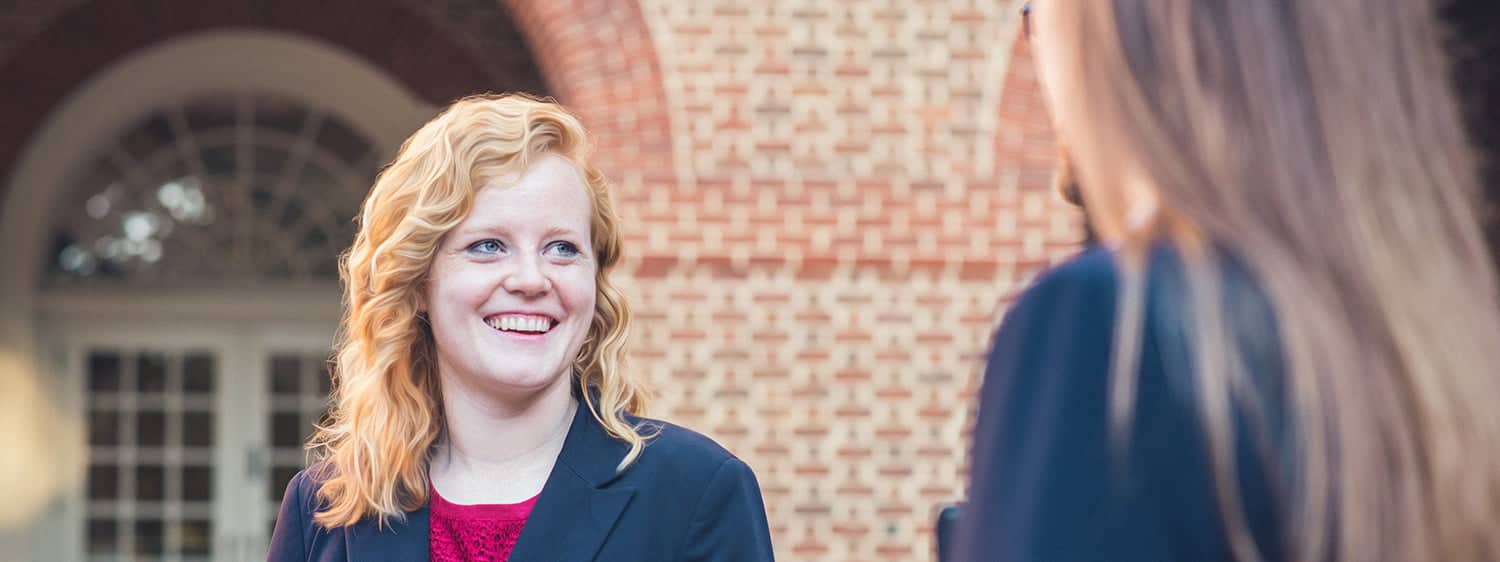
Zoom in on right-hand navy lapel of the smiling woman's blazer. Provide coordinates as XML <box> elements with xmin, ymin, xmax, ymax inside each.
<box><xmin>510</xmin><ymin>400</ymin><xmax>635</xmax><ymax>562</ymax></box>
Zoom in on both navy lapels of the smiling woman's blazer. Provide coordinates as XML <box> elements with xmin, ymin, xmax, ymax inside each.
<box><xmin>345</xmin><ymin>400</ymin><xmax>635</xmax><ymax>562</ymax></box>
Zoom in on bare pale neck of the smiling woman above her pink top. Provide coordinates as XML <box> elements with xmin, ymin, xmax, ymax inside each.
<box><xmin>429</xmin><ymin>378</ymin><xmax>578</xmax><ymax>504</ymax></box>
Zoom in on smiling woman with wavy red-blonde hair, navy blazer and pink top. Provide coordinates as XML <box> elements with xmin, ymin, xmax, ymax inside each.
<box><xmin>270</xmin><ymin>96</ymin><xmax>771</xmax><ymax>561</ymax></box>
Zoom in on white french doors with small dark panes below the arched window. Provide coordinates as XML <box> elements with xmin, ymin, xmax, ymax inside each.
<box><xmin>51</xmin><ymin>313</ymin><xmax>340</xmax><ymax>562</ymax></box>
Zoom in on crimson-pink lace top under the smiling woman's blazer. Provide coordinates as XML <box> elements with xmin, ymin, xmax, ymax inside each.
<box><xmin>428</xmin><ymin>487</ymin><xmax>537</xmax><ymax>562</ymax></box>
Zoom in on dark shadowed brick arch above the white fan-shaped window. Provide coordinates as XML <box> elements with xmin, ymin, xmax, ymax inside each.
<box><xmin>0</xmin><ymin>0</ymin><xmax>548</xmax><ymax>205</ymax></box>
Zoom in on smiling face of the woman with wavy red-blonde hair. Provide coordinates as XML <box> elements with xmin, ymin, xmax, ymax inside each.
<box><xmin>425</xmin><ymin>154</ymin><xmax>599</xmax><ymax>397</ymax></box>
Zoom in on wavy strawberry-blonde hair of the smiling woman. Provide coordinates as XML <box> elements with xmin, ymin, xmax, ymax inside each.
<box><xmin>308</xmin><ymin>94</ymin><xmax>645</xmax><ymax>528</ymax></box>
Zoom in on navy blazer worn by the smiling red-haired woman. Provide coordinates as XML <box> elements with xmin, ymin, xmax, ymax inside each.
<box><xmin>267</xmin><ymin>408</ymin><xmax>773</xmax><ymax>562</ymax></box>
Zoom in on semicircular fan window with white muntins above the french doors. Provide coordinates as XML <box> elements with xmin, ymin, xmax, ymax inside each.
<box><xmin>45</xmin><ymin>91</ymin><xmax>380</xmax><ymax>288</ymax></box>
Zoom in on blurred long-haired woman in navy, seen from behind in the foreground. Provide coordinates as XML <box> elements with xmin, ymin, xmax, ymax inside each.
<box><xmin>960</xmin><ymin>0</ymin><xmax>1500</xmax><ymax>562</ymax></box>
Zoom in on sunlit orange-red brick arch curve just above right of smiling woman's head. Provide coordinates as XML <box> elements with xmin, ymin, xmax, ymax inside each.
<box><xmin>497</xmin><ymin>0</ymin><xmax>672</xmax><ymax>178</ymax></box>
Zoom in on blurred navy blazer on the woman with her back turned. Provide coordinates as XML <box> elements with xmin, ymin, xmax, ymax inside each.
<box><xmin>957</xmin><ymin>247</ymin><xmax>1287</xmax><ymax>562</ymax></box>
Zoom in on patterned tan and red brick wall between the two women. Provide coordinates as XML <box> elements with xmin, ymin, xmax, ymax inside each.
<box><xmin>617</xmin><ymin>0</ymin><xmax>1080</xmax><ymax>562</ymax></box>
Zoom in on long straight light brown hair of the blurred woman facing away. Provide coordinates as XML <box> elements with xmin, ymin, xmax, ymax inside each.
<box><xmin>1038</xmin><ymin>0</ymin><xmax>1500</xmax><ymax>561</ymax></box>
